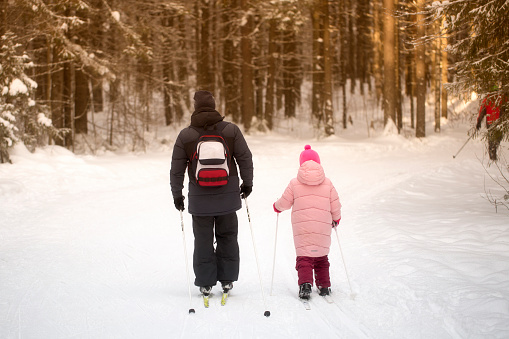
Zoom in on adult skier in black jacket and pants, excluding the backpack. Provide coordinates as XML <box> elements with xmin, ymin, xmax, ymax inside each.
<box><xmin>170</xmin><ymin>91</ymin><xmax>253</xmax><ymax>297</ymax></box>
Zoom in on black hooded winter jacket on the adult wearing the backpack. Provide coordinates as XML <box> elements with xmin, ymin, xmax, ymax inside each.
<box><xmin>170</xmin><ymin>108</ymin><xmax>253</xmax><ymax>216</ymax></box>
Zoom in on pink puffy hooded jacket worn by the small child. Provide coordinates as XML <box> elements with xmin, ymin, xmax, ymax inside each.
<box><xmin>274</xmin><ymin>160</ymin><xmax>341</xmax><ymax>257</ymax></box>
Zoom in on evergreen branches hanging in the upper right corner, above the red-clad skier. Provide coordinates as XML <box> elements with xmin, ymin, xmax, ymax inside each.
<box><xmin>432</xmin><ymin>0</ymin><xmax>509</xmax><ymax>140</ymax></box>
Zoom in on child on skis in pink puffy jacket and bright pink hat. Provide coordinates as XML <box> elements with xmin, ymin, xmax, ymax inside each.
<box><xmin>273</xmin><ymin>145</ymin><xmax>341</xmax><ymax>299</ymax></box>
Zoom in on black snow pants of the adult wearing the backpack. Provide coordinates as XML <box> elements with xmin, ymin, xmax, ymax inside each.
<box><xmin>193</xmin><ymin>212</ymin><xmax>240</xmax><ymax>286</ymax></box>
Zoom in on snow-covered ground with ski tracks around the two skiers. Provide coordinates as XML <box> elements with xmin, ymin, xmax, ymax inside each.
<box><xmin>0</xmin><ymin>121</ymin><xmax>509</xmax><ymax>338</ymax></box>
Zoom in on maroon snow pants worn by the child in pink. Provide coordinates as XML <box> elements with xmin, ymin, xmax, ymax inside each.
<box><xmin>295</xmin><ymin>255</ymin><xmax>330</xmax><ymax>287</ymax></box>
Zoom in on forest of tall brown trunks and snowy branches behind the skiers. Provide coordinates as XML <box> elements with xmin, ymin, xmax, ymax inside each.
<box><xmin>0</xmin><ymin>0</ymin><xmax>509</xmax><ymax>162</ymax></box>
